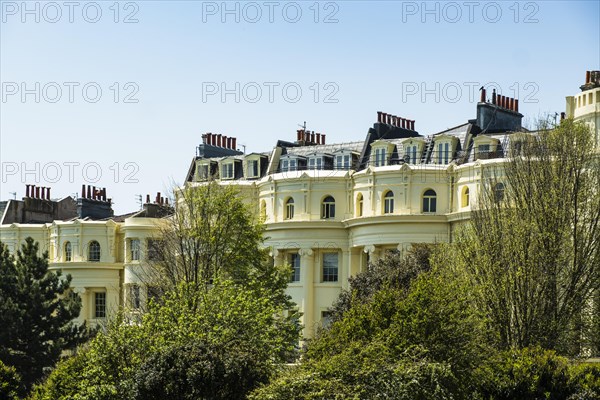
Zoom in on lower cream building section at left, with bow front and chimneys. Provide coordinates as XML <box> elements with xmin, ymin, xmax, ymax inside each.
<box><xmin>0</xmin><ymin>185</ymin><xmax>170</xmax><ymax>325</ymax></box>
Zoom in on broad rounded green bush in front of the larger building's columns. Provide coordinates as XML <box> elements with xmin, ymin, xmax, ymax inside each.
<box><xmin>252</xmin><ymin>247</ymin><xmax>488</xmax><ymax>399</ymax></box>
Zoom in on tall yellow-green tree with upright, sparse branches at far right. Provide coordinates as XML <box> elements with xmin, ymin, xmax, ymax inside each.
<box><xmin>454</xmin><ymin>120</ymin><xmax>600</xmax><ymax>355</ymax></box>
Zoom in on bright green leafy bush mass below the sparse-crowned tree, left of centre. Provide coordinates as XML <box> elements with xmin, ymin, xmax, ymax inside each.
<box><xmin>36</xmin><ymin>281</ymin><xmax>300</xmax><ymax>400</ymax></box>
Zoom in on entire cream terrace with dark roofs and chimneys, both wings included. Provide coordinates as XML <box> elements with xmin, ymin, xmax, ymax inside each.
<box><xmin>0</xmin><ymin>71</ymin><xmax>600</xmax><ymax>336</ymax></box>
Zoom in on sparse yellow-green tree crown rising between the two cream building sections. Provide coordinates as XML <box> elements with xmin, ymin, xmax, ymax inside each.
<box><xmin>145</xmin><ymin>182</ymin><xmax>266</xmax><ymax>288</ymax></box>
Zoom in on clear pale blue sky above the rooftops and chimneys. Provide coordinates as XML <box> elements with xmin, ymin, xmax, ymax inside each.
<box><xmin>0</xmin><ymin>0</ymin><xmax>600</xmax><ymax>214</ymax></box>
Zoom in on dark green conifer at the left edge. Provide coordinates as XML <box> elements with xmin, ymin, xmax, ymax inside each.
<box><xmin>0</xmin><ymin>237</ymin><xmax>86</xmax><ymax>390</ymax></box>
